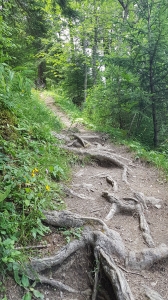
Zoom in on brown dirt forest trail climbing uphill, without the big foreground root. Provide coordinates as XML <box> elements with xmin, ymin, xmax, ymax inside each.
<box><xmin>35</xmin><ymin>97</ymin><xmax>168</xmax><ymax>300</ymax></box>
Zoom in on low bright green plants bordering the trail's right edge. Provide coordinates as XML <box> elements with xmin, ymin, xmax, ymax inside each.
<box><xmin>52</xmin><ymin>86</ymin><xmax>168</xmax><ymax>174</ymax></box>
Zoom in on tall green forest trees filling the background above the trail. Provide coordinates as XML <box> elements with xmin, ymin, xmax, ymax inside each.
<box><xmin>0</xmin><ymin>0</ymin><xmax>168</xmax><ymax>147</ymax></box>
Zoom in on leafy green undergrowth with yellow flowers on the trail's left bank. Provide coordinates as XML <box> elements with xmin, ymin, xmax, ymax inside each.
<box><xmin>0</xmin><ymin>65</ymin><xmax>73</xmax><ymax>300</ymax></box>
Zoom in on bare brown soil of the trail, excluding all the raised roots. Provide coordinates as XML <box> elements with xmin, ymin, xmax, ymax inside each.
<box><xmin>0</xmin><ymin>97</ymin><xmax>168</xmax><ymax>300</ymax></box>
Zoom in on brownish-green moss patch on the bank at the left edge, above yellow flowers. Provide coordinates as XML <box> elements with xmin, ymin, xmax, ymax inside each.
<box><xmin>0</xmin><ymin>109</ymin><xmax>17</xmax><ymax>140</ymax></box>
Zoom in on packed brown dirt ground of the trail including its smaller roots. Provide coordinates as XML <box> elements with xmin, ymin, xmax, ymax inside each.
<box><xmin>0</xmin><ymin>97</ymin><xmax>168</xmax><ymax>300</ymax></box>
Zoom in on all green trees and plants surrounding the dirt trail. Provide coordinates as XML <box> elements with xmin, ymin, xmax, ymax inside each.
<box><xmin>0</xmin><ymin>0</ymin><xmax>168</xmax><ymax>298</ymax></box>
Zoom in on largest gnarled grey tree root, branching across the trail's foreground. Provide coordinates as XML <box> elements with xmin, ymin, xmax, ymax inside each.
<box><xmin>23</xmin><ymin>211</ymin><xmax>168</xmax><ymax>300</ymax></box>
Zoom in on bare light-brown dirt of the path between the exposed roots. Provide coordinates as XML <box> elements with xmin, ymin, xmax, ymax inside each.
<box><xmin>38</xmin><ymin>98</ymin><xmax>168</xmax><ymax>300</ymax></box>
